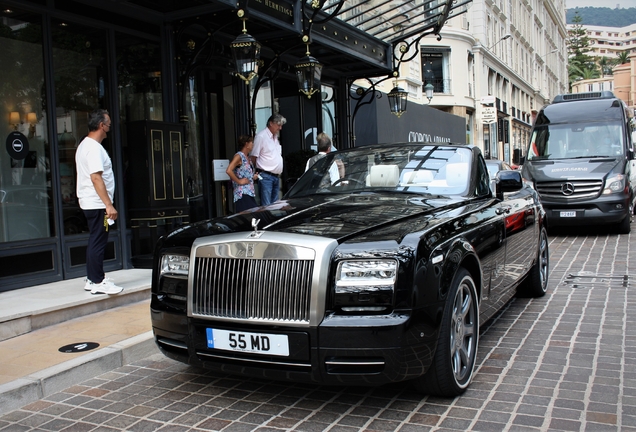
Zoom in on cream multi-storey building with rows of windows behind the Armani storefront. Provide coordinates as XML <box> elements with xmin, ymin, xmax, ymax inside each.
<box><xmin>366</xmin><ymin>0</ymin><xmax>568</xmax><ymax>162</ymax></box>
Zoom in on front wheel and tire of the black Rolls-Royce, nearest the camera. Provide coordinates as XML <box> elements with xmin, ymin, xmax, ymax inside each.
<box><xmin>414</xmin><ymin>268</ymin><xmax>479</xmax><ymax>397</ymax></box>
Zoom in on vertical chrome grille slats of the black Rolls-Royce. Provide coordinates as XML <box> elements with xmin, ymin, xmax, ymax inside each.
<box><xmin>192</xmin><ymin>257</ymin><xmax>314</xmax><ymax>323</ymax></box>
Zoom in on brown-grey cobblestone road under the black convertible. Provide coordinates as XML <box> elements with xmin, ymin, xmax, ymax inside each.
<box><xmin>0</xmin><ymin>225</ymin><xmax>636</xmax><ymax>432</ymax></box>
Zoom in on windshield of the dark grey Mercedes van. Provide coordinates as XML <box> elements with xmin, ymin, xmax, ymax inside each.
<box><xmin>527</xmin><ymin>121</ymin><xmax>624</xmax><ymax>160</ymax></box>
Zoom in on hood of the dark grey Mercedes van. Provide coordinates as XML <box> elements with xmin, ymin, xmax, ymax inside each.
<box><xmin>523</xmin><ymin>157</ymin><xmax>622</xmax><ymax>182</ymax></box>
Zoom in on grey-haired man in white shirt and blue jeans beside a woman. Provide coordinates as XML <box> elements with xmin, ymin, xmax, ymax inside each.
<box><xmin>250</xmin><ymin>114</ymin><xmax>287</xmax><ymax>205</ymax></box>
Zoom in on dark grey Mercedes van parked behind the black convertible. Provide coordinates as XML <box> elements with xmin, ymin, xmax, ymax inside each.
<box><xmin>522</xmin><ymin>91</ymin><xmax>636</xmax><ymax>234</ymax></box>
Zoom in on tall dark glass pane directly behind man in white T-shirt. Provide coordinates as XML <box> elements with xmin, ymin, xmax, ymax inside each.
<box><xmin>51</xmin><ymin>20</ymin><xmax>109</xmax><ymax>234</ymax></box>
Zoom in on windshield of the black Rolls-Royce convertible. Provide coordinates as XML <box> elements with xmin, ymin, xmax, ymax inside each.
<box><xmin>287</xmin><ymin>144</ymin><xmax>472</xmax><ymax>198</ymax></box>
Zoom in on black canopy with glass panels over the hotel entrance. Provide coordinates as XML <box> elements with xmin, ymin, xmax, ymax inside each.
<box><xmin>4</xmin><ymin>0</ymin><xmax>472</xmax><ymax>82</ymax></box>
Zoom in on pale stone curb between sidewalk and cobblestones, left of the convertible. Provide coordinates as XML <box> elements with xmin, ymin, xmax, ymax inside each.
<box><xmin>0</xmin><ymin>330</ymin><xmax>159</xmax><ymax>415</ymax></box>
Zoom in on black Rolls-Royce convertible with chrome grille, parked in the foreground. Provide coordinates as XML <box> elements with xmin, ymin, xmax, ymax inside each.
<box><xmin>151</xmin><ymin>143</ymin><xmax>549</xmax><ymax>396</ymax></box>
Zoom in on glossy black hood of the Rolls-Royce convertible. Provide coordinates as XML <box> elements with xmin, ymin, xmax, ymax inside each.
<box><xmin>160</xmin><ymin>193</ymin><xmax>466</xmax><ymax>247</ymax></box>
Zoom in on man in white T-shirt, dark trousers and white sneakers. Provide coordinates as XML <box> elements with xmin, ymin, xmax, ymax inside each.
<box><xmin>75</xmin><ymin>109</ymin><xmax>123</xmax><ymax>294</ymax></box>
